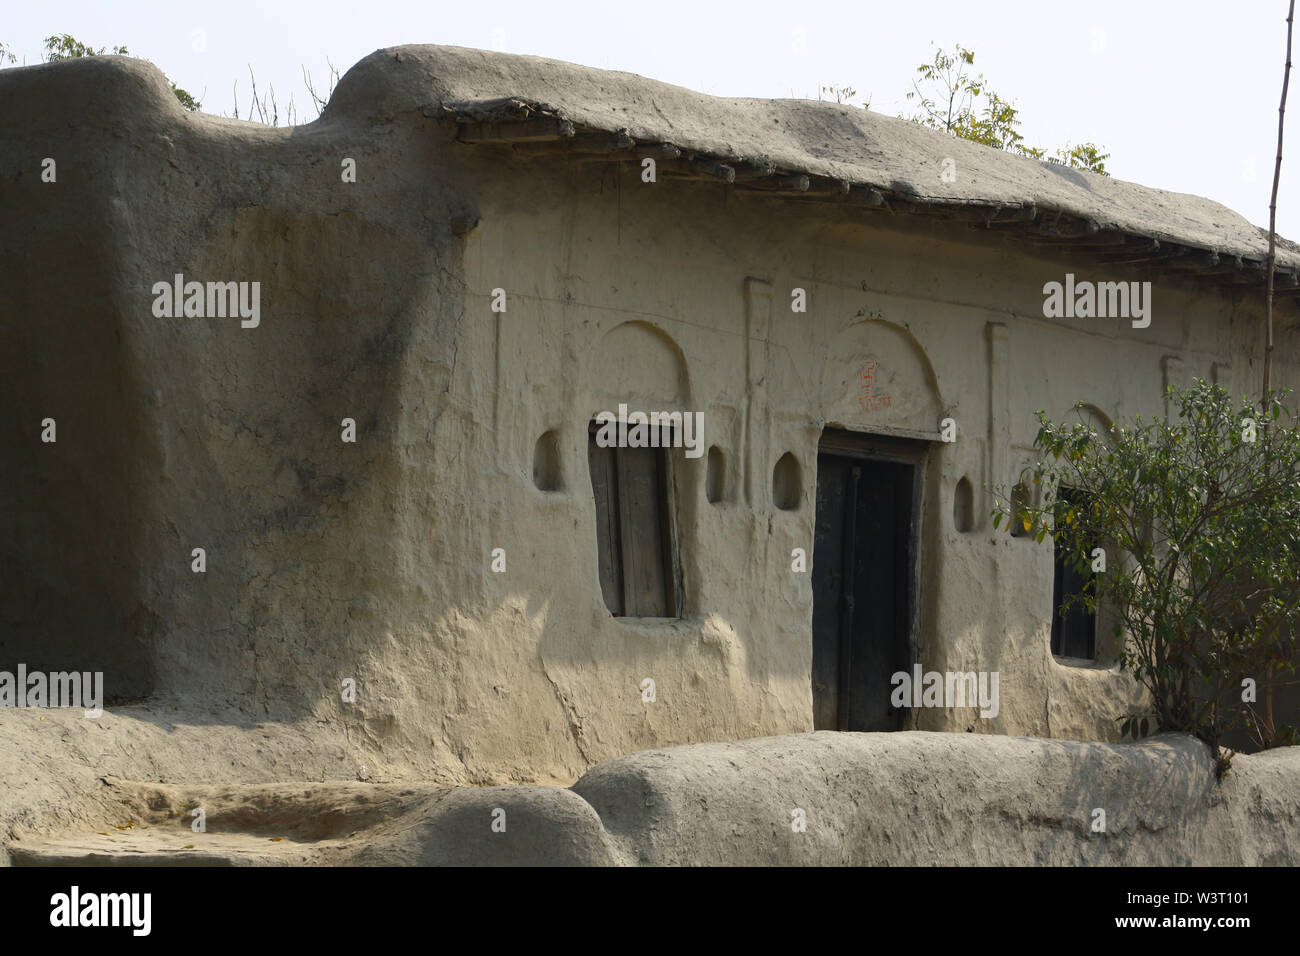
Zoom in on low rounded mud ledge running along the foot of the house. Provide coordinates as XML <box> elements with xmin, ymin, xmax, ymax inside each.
<box><xmin>0</xmin><ymin>711</ymin><xmax>1300</xmax><ymax>866</ymax></box>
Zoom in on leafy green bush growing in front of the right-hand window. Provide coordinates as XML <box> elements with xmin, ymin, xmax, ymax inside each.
<box><xmin>993</xmin><ymin>380</ymin><xmax>1300</xmax><ymax>771</ymax></box>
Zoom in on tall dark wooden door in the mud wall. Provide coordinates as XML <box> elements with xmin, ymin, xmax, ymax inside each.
<box><xmin>813</xmin><ymin>450</ymin><xmax>917</xmax><ymax>731</ymax></box>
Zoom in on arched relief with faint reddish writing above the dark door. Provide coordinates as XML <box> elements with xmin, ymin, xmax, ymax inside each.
<box><xmin>822</xmin><ymin>319</ymin><xmax>944</xmax><ymax>436</ymax></box>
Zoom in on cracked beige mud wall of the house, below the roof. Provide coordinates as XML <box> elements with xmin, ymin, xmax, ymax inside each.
<box><xmin>0</xmin><ymin>48</ymin><xmax>1296</xmax><ymax>783</ymax></box>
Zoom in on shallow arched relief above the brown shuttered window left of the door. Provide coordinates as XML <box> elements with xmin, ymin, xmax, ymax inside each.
<box><xmin>586</xmin><ymin>320</ymin><xmax>694</xmax><ymax>411</ymax></box>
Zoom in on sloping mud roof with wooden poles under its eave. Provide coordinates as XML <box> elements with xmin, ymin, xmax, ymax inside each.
<box><xmin>325</xmin><ymin>46</ymin><xmax>1300</xmax><ymax>290</ymax></box>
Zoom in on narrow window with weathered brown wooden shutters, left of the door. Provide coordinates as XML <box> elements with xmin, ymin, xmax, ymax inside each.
<box><xmin>588</xmin><ymin>424</ymin><xmax>681</xmax><ymax>618</ymax></box>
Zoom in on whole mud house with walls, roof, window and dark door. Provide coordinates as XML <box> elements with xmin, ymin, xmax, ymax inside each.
<box><xmin>0</xmin><ymin>47</ymin><xmax>1300</xmax><ymax>782</ymax></box>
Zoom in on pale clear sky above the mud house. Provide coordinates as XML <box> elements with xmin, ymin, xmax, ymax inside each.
<box><xmin>0</xmin><ymin>0</ymin><xmax>1300</xmax><ymax>239</ymax></box>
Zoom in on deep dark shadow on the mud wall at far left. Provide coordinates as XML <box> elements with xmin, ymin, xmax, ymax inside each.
<box><xmin>0</xmin><ymin>175</ymin><xmax>159</xmax><ymax>700</ymax></box>
